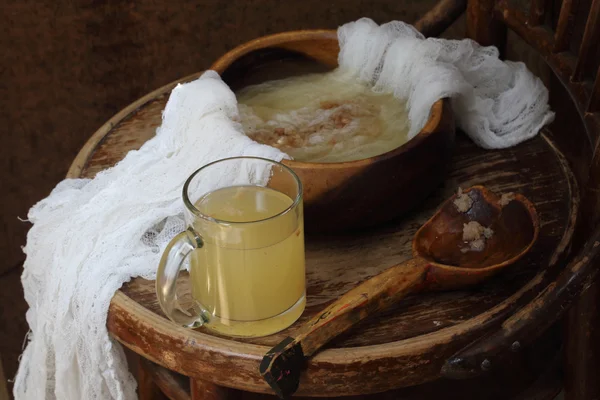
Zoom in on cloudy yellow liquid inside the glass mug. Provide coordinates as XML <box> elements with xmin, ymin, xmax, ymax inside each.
<box><xmin>190</xmin><ymin>186</ymin><xmax>306</xmax><ymax>337</ymax></box>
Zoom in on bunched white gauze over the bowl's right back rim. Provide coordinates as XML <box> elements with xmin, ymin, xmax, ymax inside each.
<box><xmin>338</xmin><ymin>18</ymin><xmax>554</xmax><ymax>149</ymax></box>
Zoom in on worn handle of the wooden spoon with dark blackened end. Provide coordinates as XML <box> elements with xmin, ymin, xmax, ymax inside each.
<box><xmin>260</xmin><ymin>257</ymin><xmax>429</xmax><ymax>398</ymax></box>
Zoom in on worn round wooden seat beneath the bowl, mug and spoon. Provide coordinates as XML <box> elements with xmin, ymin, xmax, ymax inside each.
<box><xmin>70</xmin><ymin>69</ymin><xmax>577</xmax><ymax>395</ymax></box>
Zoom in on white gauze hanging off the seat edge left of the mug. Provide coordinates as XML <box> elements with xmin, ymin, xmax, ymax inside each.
<box><xmin>14</xmin><ymin>71</ymin><xmax>287</xmax><ymax>400</ymax></box>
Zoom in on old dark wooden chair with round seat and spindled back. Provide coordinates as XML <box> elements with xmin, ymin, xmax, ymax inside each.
<box><xmin>68</xmin><ymin>1</ymin><xmax>600</xmax><ymax>399</ymax></box>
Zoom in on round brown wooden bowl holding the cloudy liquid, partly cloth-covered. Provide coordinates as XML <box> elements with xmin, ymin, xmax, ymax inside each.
<box><xmin>211</xmin><ymin>30</ymin><xmax>454</xmax><ymax>231</ymax></box>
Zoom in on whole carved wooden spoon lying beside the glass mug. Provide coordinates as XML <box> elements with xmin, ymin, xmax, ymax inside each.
<box><xmin>260</xmin><ymin>186</ymin><xmax>539</xmax><ymax>398</ymax></box>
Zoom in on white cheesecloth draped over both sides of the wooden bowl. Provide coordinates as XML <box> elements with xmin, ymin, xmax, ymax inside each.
<box><xmin>14</xmin><ymin>19</ymin><xmax>553</xmax><ymax>400</ymax></box>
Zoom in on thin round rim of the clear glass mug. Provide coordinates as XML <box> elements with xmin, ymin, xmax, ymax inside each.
<box><xmin>182</xmin><ymin>156</ymin><xmax>304</xmax><ymax>225</ymax></box>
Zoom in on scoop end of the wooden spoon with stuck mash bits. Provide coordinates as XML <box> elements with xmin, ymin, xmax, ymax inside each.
<box><xmin>413</xmin><ymin>186</ymin><xmax>539</xmax><ymax>289</ymax></box>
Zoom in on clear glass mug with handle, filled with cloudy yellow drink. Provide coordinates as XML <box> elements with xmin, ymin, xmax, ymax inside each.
<box><xmin>156</xmin><ymin>157</ymin><xmax>306</xmax><ymax>337</ymax></box>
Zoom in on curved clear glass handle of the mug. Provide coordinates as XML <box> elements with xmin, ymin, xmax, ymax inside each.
<box><xmin>156</xmin><ymin>228</ymin><xmax>209</xmax><ymax>328</ymax></box>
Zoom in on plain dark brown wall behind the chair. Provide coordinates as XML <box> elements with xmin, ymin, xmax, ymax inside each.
<box><xmin>0</xmin><ymin>0</ymin><xmax>464</xmax><ymax>394</ymax></box>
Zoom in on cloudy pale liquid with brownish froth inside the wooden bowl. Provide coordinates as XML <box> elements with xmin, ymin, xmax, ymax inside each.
<box><xmin>237</xmin><ymin>70</ymin><xmax>410</xmax><ymax>162</ymax></box>
